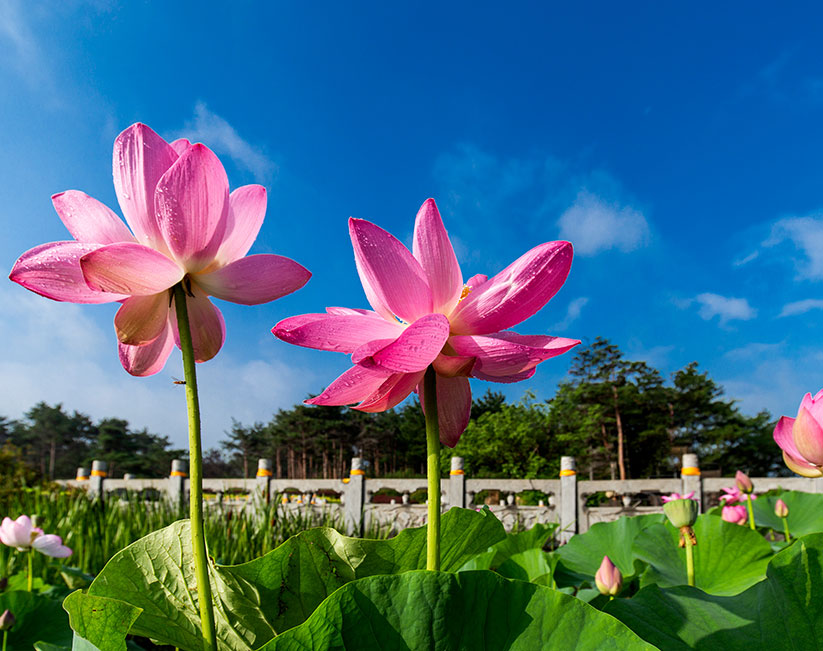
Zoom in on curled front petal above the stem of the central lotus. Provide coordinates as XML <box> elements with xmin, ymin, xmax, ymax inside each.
<box><xmin>352</xmin><ymin>314</ymin><xmax>449</xmax><ymax>373</ymax></box>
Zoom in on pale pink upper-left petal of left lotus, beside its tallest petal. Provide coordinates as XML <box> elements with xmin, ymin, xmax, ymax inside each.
<box><xmin>51</xmin><ymin>190</ymin><xmax>135</xmax><ymax>244</ymax></box>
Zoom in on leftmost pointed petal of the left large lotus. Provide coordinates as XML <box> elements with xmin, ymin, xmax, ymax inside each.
<box><xmin>9</xmin><ymin>242</ymin><xmax>127</xmax><ymax>303</ymax></box>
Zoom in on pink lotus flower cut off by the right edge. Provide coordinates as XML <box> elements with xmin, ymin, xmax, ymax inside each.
<box><xmin>774</xmin><ymin>389</ymin><xmax>823</xmax><ymax>477</ymax></box>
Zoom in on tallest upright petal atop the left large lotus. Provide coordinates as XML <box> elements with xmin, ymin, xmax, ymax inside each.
<box><xmin>112</xmin><ymin>123</ymin><xmax>177</xmax><ymax>253</ymax></box>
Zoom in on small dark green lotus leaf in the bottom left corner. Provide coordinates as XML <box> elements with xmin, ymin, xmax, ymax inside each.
<box><xmin>0</xmin><ymin>590</ymin><xmax>72</xmax><ymax>649</ymax></box>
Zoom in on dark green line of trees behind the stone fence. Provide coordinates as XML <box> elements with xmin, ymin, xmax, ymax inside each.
<box><xmin>0</xmin><ymin>338</ymin><xmax>785</xmax><ymax>478</ymax></box>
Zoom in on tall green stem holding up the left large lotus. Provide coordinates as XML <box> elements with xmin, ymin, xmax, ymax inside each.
<box><xmin>173</xmin><ymin>283</ymin><xmax>217</xmax><ymax>651</ymax></box>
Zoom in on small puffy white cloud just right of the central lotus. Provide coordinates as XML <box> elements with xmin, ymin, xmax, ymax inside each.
<box><xmin>558</xmin><ymin>190</ymin><xmax>649</xmax><ymax>255</ymax></box>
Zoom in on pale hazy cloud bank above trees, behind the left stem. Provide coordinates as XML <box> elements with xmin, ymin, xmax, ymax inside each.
<box><xmin>0</xmin><ymin>288</ymin><xmax>317</xmax><ymax>448</ymax></box>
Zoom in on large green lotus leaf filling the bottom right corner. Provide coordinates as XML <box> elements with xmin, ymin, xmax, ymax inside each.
<box><xmin>604</xmin><ymin>534</ymin><xmax>823</xmax><ymax>651</ymax></box>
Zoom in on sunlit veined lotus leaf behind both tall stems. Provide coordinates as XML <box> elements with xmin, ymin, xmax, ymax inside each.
<box><xmin>88</xmin><ymin>509</ymin><xmax>505</xmax><ymax>649</ymax></box>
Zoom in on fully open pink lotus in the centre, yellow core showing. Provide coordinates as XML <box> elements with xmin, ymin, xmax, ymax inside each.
<box><xmin>272</xmin><ymin>199</ymin><xmax>580</xmax><ymax>447</ymax></box>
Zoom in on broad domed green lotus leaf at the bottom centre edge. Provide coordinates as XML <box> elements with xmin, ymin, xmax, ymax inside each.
<box><xmin>261</xmin><ymin>570</ymin><xmax>654</xmax><ymax>651</ymax></box>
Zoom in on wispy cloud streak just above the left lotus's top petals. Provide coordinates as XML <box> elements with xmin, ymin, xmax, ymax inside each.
<box><xmin>173</xmin><ymin>102</ymin><xmax>278</xmax><ymax>183</ymax></box>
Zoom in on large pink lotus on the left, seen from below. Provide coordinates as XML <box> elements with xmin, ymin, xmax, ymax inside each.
<box><xmin>9</xmin><ymin>124</ymin><xmax>311</xmax><ymax>375</ymax></box>
